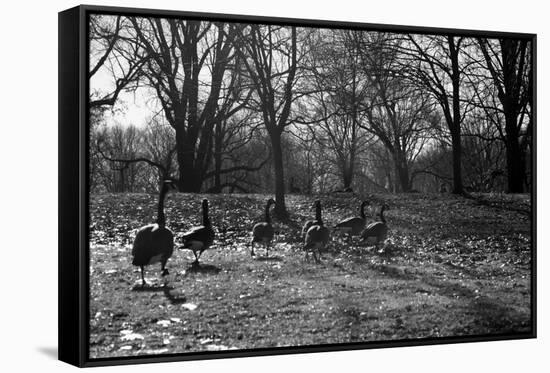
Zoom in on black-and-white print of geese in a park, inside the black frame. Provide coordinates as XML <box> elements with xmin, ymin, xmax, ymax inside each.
<box><xmin>86</xmin><ymin>5</ymin><xmax>536</xmax><ymax>360</ymax></box>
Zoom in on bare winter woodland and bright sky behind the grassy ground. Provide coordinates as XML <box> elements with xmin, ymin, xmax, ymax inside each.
<box><xmin>89</xmin><ymin>15</ymin><xmax>533</xmax><ymax>216</ymax></box>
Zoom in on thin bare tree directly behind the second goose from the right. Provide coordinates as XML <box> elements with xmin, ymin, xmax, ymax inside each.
<box><xmin>302</xmin><ymin>30</ymin><xmax>372</xmax><ymax>190</ymax></box>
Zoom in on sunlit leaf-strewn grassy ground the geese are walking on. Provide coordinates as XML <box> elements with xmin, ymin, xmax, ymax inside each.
<box><xmin>90</xmin><ymin>194</ymin><xmax>531</xmax><ymax>358</ymax></box>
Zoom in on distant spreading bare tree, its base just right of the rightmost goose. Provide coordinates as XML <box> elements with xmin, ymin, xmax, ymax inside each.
<box><xmin>356</xmin><ymin>33</ymin><xmax>440</xmax><ymax>192</ymax></box>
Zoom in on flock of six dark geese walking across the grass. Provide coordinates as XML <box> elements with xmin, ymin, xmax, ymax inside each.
<box><xmin>132</xmin><ymin>180</ymin><xmax>388</xmax><ymax>286</ymax></box>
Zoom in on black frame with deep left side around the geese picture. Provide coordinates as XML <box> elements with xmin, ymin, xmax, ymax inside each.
<box><xmin>58</xmin><ymin>5</ymin><xmax>537</xmax><ymax>367</ymax></box>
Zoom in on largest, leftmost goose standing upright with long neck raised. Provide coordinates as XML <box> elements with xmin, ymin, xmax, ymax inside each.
<box><xmin>132</xmin><ymin>180</ymin><xmax>176</xmax><ymax>286</ymax></box>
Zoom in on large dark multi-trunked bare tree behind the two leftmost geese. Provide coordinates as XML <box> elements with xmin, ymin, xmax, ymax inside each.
<box><xmin>125</xmin><ymin>17</ymin><xmax>264</xmax><ymax>192</ymax></box>
